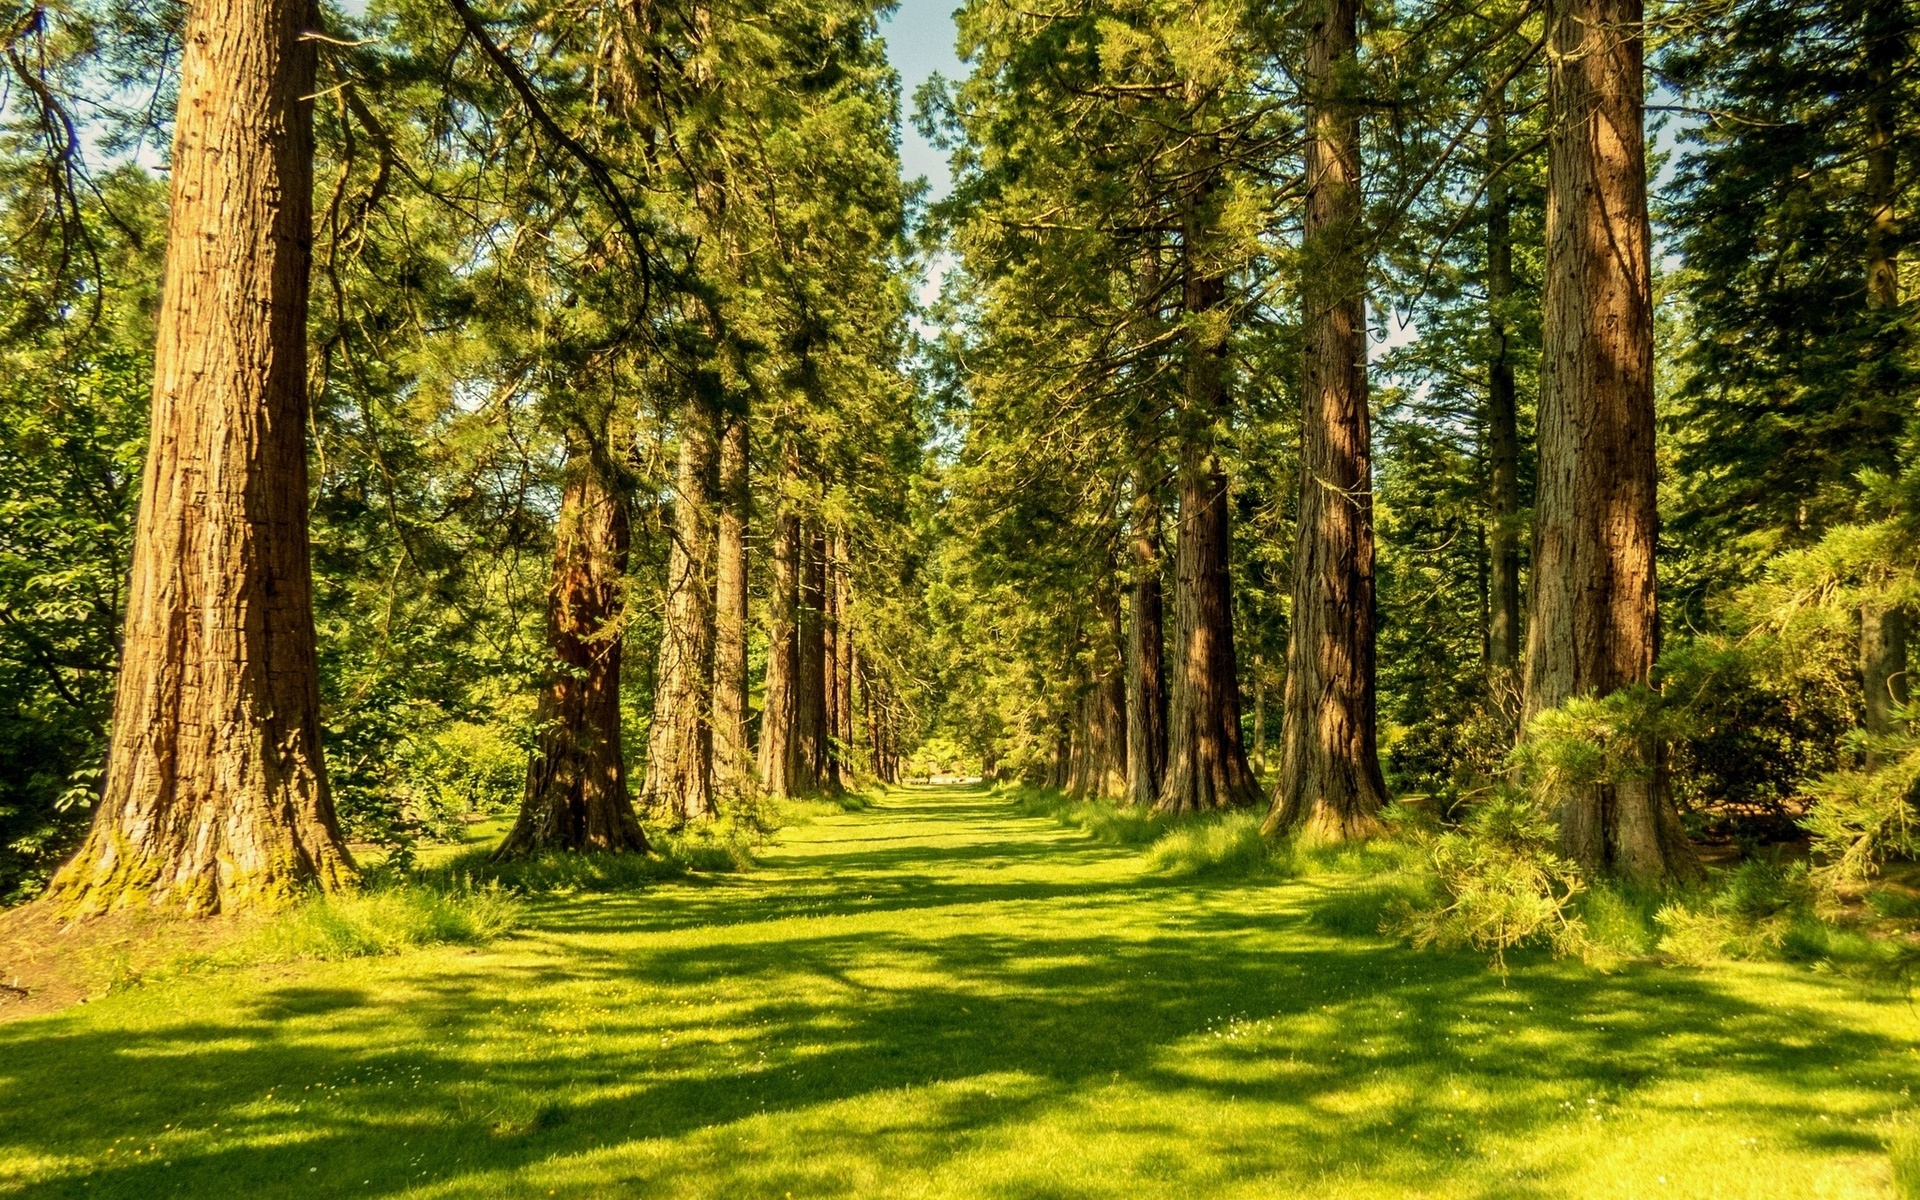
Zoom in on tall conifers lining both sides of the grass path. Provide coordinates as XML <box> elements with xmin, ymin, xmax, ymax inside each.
<box><xmin>0</xmin><ymin>0</ymin><xmax>1920</xmax><ymax>912</ymax></box>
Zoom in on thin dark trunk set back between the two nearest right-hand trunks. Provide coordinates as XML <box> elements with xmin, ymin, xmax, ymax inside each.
<box><xmin>1486</xmin><ymin>90</ymin><xmax>1521</xmax><ymax>674</ymax></box>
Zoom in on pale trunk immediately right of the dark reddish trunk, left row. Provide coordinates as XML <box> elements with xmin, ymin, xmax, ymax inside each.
<box><xmin>641</xmin><ymin>399</ymin><xmax>716</xmax><ymax>826</ymax></box>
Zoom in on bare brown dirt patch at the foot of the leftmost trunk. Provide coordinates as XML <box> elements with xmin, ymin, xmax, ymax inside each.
<box><xmin>0</xmin><ymin>902</ymin><xmax>255</xmax><ymax>1021</ymax></box>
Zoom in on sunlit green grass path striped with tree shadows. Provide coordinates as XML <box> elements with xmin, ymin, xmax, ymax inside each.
<box><xmin>0</xmin><ymin>787</ymin><xmax>1920</xmax><ymax>1200</ymax></box>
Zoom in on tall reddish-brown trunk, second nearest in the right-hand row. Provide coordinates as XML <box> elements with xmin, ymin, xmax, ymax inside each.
<box><xmin>1265</xmin><ymin>0</ymin><xmax>1386</xmax><ymax>841</ymax></box>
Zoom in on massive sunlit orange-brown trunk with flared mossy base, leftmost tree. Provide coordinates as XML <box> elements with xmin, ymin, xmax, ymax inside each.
<box><xmin>52</xmin><ymin>0</ymin><xmax>355</xmax><ymax>914</ymax></box>
